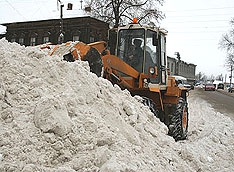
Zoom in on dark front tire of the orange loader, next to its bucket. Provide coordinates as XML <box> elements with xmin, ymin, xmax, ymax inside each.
<box><xmin>84</xmin><ymin>47</ymin><xmax>103</xmax><ymax>77</ymax></box>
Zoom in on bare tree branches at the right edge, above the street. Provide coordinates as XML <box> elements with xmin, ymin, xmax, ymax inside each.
<box><xmin>219</xmin><ymin>18</ymin><xmax>234</xmax><ymax>68</ymax></box>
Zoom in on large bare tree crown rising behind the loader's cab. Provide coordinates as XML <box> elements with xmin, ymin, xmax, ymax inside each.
<box><xmin>86</xmin><ymin>0</ymin><xmax>164</xmax><ymax>27</ymax></box>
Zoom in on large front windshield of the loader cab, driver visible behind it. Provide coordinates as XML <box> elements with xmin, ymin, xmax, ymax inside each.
<box><xmin>117</xmin><ymin>29</ymin><xmax>145</xmax><ymax>72</ymax></box>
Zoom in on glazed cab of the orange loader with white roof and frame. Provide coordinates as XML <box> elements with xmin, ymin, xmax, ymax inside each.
<box><xmin>115</xmin><ymin>24</ymin><xmax>167</xmax><ymax>85</ymax></box>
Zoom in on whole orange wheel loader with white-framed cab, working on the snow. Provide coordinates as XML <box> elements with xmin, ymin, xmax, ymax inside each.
<box><xmin>46</xmin><ymin>19</ymin><xmax>188</xmax><ymax>141</ymax></box>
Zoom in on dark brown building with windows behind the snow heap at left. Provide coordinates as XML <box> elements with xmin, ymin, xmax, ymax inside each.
<box><xmin>1</xmin><ymin>16</ymin><xmax>109</xmax><ymax>46</ymax></box>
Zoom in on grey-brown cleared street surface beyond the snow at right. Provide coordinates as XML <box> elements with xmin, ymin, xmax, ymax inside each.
<box><xmin>190</xmin><ymin>88</ymin><xmax>234</xmax><ymax>120</ymax></box>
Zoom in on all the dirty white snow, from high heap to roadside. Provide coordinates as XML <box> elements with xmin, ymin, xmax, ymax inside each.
<box><xmin>0</xmin><ymin>39</ymin><xmax>234</xmax><ymax>172</ymax></box>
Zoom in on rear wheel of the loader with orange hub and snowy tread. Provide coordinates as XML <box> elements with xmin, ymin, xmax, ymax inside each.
<box><xmin>168</xmin><ymin>98</ymin><xmax>188</xmax><ymax>141</ymax></box>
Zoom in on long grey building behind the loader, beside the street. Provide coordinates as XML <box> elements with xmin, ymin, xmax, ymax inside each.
<box><xmin>167</xmin><ymin>56</ymin><xmax>196</xmax><ymax>84</ymax></box>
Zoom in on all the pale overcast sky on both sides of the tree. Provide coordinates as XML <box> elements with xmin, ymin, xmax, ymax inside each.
<box><xmin>0</xmin><ymin>0</ymin><xmax>234</xmax><ymax>78</ymax></box>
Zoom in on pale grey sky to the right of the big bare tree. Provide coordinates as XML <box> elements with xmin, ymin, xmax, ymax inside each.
<box><xmin>161</xmin><ymin>0</ymin><xmax>234</xmax><ymax>78</ymax></box>
